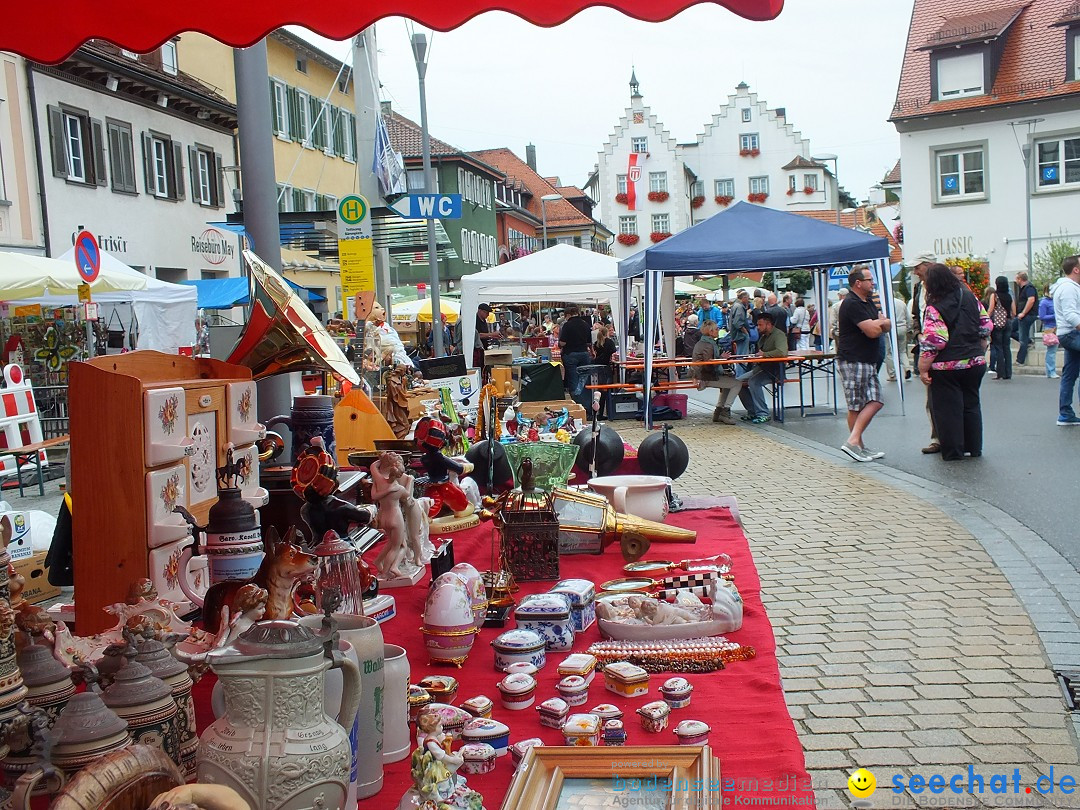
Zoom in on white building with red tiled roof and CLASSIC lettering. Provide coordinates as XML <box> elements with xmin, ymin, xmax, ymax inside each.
<box><xmin>890</xmin><ymin>0</ymin><xmax>1080</xmax><ymax>280</ymax></box>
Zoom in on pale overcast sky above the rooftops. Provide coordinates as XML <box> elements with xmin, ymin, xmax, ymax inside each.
<box><xmin>298</xmin><ymin>0</ymin><xmax>914</xmax><ymax>199</ymax></box>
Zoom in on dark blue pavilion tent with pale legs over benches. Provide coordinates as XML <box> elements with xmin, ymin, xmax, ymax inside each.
<box><xmin>619</xmin><ymin>202</ymin><xmax>904</xmax><ymax>427</ymax></box>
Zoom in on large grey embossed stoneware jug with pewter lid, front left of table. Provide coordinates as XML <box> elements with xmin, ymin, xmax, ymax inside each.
<box><xmin>198</xmin><ymin>620</ymin><xmax>361</xmax><ymax>810</ymax></box>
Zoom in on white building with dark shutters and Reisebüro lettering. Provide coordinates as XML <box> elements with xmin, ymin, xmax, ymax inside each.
<box><xmin>28</xmin><ymin>40</ymin><xmax>240</xmax><ymax>282</ymax></box>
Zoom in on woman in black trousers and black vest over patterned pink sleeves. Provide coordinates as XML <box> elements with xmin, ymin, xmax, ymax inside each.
<box><xmin>919</xmin><ymin>265</ymin><xmax>993</xmax><ymax>461</ymax></box>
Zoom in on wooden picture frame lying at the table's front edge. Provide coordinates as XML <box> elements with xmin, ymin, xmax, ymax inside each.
<box><xmin>501</xmin><ymin>745</ymin><xmax>724</xmax><ymax>810</ymax></box>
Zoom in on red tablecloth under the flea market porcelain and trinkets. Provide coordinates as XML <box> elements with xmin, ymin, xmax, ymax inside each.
<box><xmin>197</xmin><ymin>509</ymin><xmax>813</xmax><ymax>810</ymax></box>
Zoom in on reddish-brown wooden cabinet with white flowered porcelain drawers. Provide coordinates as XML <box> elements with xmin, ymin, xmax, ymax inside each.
<box><xmin>68</xmin><ymin>351</ymin><xmax>262</xmax><ymax>635</ymax></box>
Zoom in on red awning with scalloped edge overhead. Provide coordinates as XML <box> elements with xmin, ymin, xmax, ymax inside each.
<box><xmin>0</xmin><ymin>0</ymin><xmax>784</xmax><ymax>63</ymax></box>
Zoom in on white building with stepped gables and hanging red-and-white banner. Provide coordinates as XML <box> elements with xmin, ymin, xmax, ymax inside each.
<box><xmin>585</xmin><ymin>76</ymin><xmax>837</xmax><ymax>258</ymax></box>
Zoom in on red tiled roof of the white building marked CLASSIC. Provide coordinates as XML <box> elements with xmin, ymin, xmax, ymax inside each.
<box><xmin>890</xmin><ymin>0</ymin><xmax>1080</xmax><ymax>121</ymax></box>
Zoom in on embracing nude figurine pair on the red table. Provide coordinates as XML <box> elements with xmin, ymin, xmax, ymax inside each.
<box><xmin>370</xmin><ymin>451</ymin><xmax>422</xmax><ymax>580</ymax></box>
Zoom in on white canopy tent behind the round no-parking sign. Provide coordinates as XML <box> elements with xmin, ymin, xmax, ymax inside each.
<box><xmin>45</xmin><ymin>247</ymin><xmax>199</xmax><ymax>354</ymax></box>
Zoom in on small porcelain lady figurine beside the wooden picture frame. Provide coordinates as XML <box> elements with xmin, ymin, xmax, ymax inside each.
<box><xmin>397</xmin><ymin>712</ymin><xmax>484</xmax><ymax>810</ymax></box>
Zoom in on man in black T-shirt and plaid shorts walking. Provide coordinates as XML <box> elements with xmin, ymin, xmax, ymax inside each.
<box><xmin>836</xmin><ymin>265</ymin><xmax>892</xmax><ymax>461</ymax></box>
